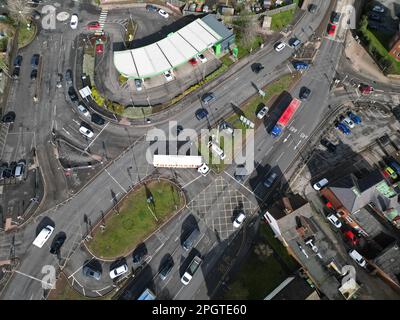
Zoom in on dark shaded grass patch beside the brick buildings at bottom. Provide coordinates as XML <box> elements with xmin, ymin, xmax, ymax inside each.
<box><xmin>224</xmin><ymin>225</ymin><xmax>297</xmax><ymax>300</ymax></box>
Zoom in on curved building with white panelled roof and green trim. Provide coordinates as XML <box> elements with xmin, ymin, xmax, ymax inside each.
<box><xmin>114</xmin><ymin>14</ymin><xmax>235</xmax><ymax>79</ymax></box>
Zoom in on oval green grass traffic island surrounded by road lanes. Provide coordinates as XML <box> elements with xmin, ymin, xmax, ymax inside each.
<box><xmin>88</xmin><ymin>180</ymin><xmax>184</xmax><ymax>258</ymax></box>
